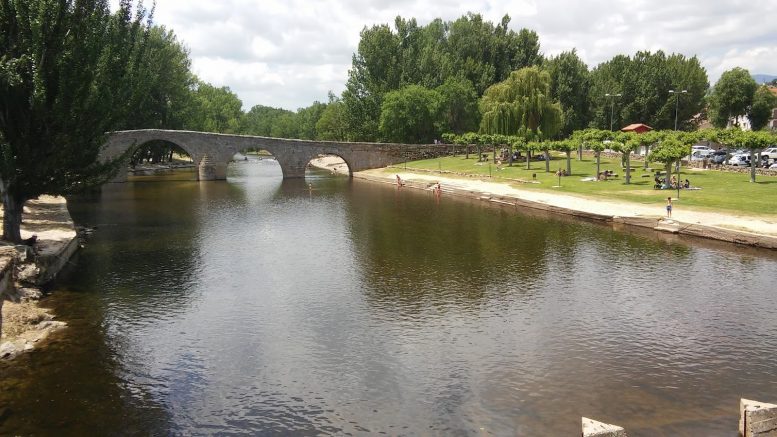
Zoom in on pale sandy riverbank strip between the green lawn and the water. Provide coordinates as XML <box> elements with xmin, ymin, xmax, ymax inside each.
<box><xmin>354</xmin><ymin>168</ymin><xmax>777</xmax><ymax>250</ymax></box>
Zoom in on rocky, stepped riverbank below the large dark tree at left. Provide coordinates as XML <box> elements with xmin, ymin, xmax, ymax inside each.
<box><xmin>0</xmin><ymin>196</ymin><xmax>78</xmax><ymax>360</ymax></box>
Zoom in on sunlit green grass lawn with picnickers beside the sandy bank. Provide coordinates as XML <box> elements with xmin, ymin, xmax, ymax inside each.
<box><xmin>394</xmin><ymin>153</ymin><xmax>777</xmax><ymax>215</ymax></box>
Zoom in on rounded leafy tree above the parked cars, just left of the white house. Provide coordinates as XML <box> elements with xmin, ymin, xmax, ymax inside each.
<box><xmin>709</xmin><ymin>67</ymin><xmax>758</xmax><ymax>129</ymax></box>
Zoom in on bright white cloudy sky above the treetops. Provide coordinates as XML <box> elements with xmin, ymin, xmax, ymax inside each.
<box><xmin>141</xmin><ymin>0</ymin><xmax>777</xmax><ymax>110</ymax></box>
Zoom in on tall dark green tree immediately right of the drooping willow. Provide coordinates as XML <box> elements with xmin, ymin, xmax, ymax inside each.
<box><xmin>543</xmin><ymin>50</ymin><xmax>591</xmax><ymax>137</ymax></box>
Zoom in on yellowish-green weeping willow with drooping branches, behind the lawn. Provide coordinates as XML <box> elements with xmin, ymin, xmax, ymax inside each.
<box><xmin>480</xmin><ymin>67</ymin><xmax>563</xmax><ymax>139</ymax></box>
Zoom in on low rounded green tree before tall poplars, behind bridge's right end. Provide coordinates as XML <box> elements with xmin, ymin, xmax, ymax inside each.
<box><xmin>380</xmin><ymin>85</ymin><xmax>442</xmax><ymax>143</ymax></box>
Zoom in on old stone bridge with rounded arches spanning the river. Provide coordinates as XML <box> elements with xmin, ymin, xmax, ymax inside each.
<box><xmin>100</xmin><ymin>129</ymin><xmax>454</xmax><ymax>182</ymax></box>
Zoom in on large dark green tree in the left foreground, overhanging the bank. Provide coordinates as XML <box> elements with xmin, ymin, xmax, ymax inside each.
<box><xmin>0</xmin><ymin>0</ymin><xmax>151</xmax><ymax>243</ymax></box>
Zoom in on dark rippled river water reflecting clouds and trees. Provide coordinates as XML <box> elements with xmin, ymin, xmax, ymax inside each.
<box><xmin>0</xmin><ymin>160</ymin><xmax>777</xmax><ymax>436</ymax></box>
